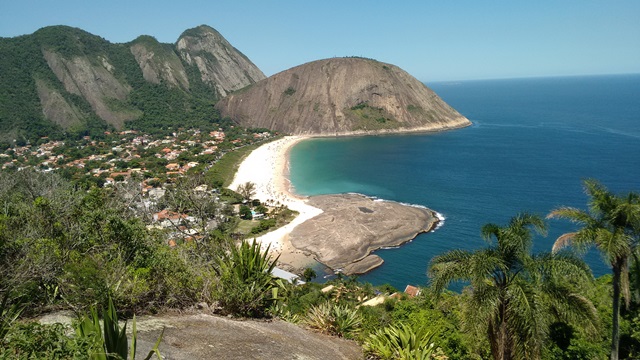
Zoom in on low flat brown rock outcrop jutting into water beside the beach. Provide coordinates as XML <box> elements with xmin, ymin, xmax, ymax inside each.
<box><xmin>289</xmin><ymin>194</ymin><xmax>439</xmax><ymax>275</ymax></box>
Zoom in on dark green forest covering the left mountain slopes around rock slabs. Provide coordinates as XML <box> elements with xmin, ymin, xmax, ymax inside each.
<box><xmin>0</xmin><ymin>26</ymin><xmax>225</xmax><ymax>147</ymax></box>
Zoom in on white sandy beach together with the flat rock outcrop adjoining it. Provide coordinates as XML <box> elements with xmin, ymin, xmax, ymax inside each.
<box><xmin>229</xmin><ymin>136</ymin><xmax>439</xmax><ymax>275</ymax></box>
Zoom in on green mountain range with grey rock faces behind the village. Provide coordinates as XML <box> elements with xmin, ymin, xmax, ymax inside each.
<box><xmin>0</xmin><ymin>25</ymin><xmax>265</xmax><ymax>142</ymax></box>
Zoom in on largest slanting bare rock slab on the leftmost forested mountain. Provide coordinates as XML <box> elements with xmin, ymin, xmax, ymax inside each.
<box><xmin>43</xmin><ymin>50</ymin><xmax>135</xmax><ymax>128</ymax></box>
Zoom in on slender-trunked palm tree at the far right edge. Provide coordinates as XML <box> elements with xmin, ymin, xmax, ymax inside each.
<box><xmin>547</xmin><ymin>180</ymin><xmax>640</xmax><ymax>360</ymax></box>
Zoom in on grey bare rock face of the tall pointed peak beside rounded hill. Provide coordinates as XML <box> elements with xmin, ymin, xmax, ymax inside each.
<box><xmin>176</xmin><ymin>25</ymin><xmax>265</xmax><ymax>97</ymax></box>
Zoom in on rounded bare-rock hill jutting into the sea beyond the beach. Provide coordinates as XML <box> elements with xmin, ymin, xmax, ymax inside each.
<box><xmin>216</xmin><ymin>58</ymin><xmax>471</xmax><ymax>135</ymax></box>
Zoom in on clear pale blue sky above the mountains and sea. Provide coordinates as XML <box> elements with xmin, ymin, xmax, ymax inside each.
<box><xmin>0</xmin><ymin>0</ymin><xmax>640</xmax><ymax>82</ymax></box>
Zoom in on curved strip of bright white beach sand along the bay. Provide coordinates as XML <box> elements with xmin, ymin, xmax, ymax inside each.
<box><xmin>229</xmin><ymin>136</ymin><xmax>322</xmax><ymax>268</ymax></box>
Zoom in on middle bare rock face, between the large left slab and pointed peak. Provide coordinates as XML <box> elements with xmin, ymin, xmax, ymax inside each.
<box><xmin>130</xmin><ymin>36</ymin><xmax>189</xmax><ymax>90</ymax></box>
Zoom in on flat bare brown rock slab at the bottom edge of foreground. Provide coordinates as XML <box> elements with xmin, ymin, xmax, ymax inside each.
<box><xmin>137</xmin><ymin>314</ymin><xmax>363</xmax><ymax>360</ymax></box>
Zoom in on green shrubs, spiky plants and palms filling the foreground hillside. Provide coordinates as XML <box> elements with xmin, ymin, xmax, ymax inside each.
<box><xmin>0</xmin><ymin>171</ymin><xmax>640</xmax><ymax>359</ymax></box>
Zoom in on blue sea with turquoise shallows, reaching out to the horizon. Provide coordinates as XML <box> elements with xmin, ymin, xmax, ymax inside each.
<box><xmin>290</xmin><ymin>75</ymin><xmax>640</xmax><ymax>289</ymax></box>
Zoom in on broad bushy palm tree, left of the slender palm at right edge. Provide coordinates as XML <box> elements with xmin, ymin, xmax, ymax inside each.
<box><xmin>428</xmin><ymin>214</ymin><xmax>596</xmax><ymax>360</ymax></box>
